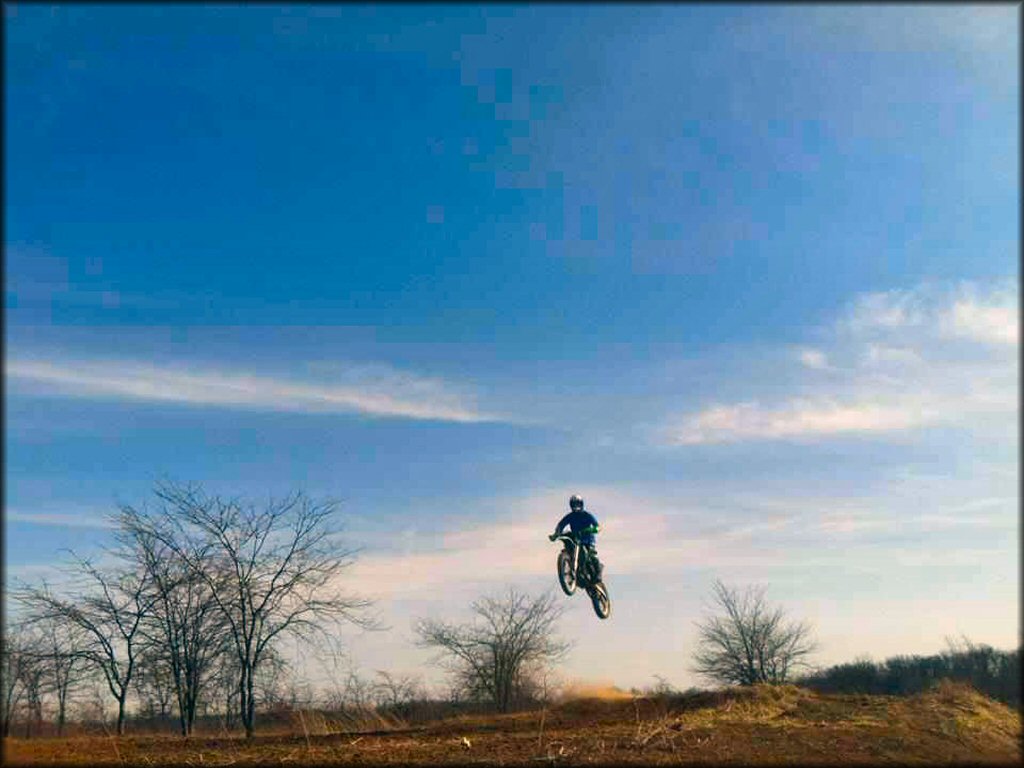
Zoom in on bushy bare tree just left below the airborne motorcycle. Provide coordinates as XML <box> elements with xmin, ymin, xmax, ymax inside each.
<box><xmin>414</xmin><ymin>589</ymin><xmax>569</xmax><ymax>712</ymax></box>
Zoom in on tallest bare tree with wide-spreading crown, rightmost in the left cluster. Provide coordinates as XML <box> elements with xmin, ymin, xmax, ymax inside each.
<box><xmin>148</xmin><ymin>484</ymin><xmax>374</xmax><ymax>737</ymax></box>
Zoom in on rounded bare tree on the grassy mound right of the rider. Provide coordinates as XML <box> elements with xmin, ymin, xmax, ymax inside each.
<box><xmin>693</xmin><ymin>582</ymin><xmax>816</xmax><ymax>685</ymax></box>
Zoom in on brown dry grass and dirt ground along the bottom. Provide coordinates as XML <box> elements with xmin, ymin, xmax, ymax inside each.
<box><xmin>4</xmin><ymin>684</ymin><xmax>1021</xmax><ymax>766</ymax></box>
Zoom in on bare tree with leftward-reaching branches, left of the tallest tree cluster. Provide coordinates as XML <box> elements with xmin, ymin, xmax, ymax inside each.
<box><xmin>14</xmin><ymin>558</ymin><xmax>152</xmax><ymax>735</ymax></box>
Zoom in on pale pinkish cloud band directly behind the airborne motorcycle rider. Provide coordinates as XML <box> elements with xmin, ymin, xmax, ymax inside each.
<box><xmin>345</xmin><ymin>477</ymin><xmax>1017</xmax><ymax>602</ymax></box>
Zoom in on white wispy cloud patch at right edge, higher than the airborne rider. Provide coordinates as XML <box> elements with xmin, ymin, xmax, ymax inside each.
<box><xmin>662</xmin><ymin>284</ymin><xmax>1020</xmax><ymax>445</ymax></box>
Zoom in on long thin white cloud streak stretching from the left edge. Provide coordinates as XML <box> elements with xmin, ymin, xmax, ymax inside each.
<box><xmin>5</xmin><ymin>358</ymin><xmax>511</xmax><ymax>423</ymax></box>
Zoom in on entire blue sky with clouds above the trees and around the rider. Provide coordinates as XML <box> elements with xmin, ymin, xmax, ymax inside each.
<box><xmin>4</xmin><ymin>4</ymin><xmax>1020</xmax><ymax>696</ymax></box>
